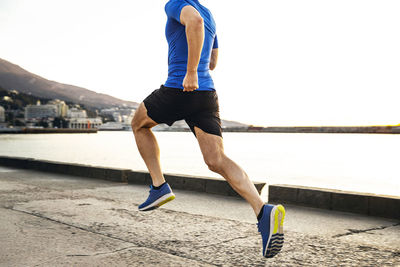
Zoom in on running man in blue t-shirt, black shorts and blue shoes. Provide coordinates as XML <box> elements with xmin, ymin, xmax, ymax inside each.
<box><xmin>132</xmin><ymin>0</ymin><xmax>285</xmax><ymax>258</ymax></box>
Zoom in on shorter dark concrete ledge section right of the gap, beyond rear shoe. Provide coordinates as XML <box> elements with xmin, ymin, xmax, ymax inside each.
<box><xmin>269</xmin><ymin>185</ymin><xmax>400</xmax><ymax>219</ymax></box>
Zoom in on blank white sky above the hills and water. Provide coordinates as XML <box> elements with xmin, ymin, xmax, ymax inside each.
<box><xmin>0</xmin><ymin>0</ymin><xmax>400</xmax><ymax>126</ymax></box>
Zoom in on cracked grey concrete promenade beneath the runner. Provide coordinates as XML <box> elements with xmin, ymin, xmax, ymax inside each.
<box><xmin>0</xmin><ymin>167</ymin><xmax>400</xmax><ymax>266</ymax></box>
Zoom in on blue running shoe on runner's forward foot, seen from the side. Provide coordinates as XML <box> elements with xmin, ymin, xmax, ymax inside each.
<box><xmin>139</xmin><ymin>183</ymin><xmax>175</xmax><ymax>211</ymax></box>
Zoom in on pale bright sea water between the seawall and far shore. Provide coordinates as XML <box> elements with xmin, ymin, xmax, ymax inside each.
<box><xmin>0</xmin><ymin>132</ymin><xmax>400</xmax><ymax>196</ymax></box>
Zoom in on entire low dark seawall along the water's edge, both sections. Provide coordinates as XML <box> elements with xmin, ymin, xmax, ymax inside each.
<box><xmin>0</xmin><ymin>156</ymin><xmax>400</xmax><ymax>219</ymax></box>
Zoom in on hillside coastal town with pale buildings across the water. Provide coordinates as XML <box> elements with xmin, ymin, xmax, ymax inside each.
<box><xmin>0</xmin><ymin>90</ymin><xmax>248</xmax><ymax>133</ymax></box>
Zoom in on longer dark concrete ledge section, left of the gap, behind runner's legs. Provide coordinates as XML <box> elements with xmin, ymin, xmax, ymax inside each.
<box><xmin>0</xmin><ymin>156</ymin><xmax>265</xmax><ymax>197</ymax></box>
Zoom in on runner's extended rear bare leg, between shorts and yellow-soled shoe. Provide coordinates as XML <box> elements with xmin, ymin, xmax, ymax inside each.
<box><xmin>195</xmin><ymin>127</ymin><xmax>264</xmax><ymax>216</ymax></box>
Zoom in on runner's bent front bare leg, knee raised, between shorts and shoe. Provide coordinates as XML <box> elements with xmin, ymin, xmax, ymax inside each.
<box><xmin>132</xmin><ymin>103</ymin><xmax>165</xmax><ymax>186</ymax></box>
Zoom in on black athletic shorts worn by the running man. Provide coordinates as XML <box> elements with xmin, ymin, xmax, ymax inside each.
<box><xmin>143</xmin><ymin>85</ymin><xmax>222</xmax><ymax>137</ymax></box>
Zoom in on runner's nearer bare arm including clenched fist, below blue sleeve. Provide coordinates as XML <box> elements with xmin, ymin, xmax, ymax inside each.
<box><xmin>180</xmin><ymin>6</ymin><xmax>204</xmax><ymax>91</ymax></box>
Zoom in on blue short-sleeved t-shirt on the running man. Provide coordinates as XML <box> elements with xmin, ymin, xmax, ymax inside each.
<box><xmin>164</xmin><ymin>0</ymin><xmax>218</xmax><ymax>91</ymax></box>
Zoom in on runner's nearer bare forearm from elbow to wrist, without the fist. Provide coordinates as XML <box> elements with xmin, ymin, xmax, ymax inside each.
<box><xmin>186</xmin><ymin>19</ymin><xmax>204</xmax><ymax>72</ymax></box>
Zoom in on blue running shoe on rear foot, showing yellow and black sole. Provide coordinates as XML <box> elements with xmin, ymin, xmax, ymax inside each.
<box><xmin>258</xmin><ymin>204</ymin><xmax>285</xmax><ymax>258</ymax></box>
